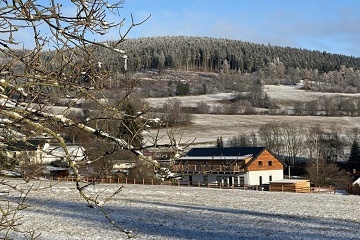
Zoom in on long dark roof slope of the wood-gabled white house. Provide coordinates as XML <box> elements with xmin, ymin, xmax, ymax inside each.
<box><xmin>186</xmin><ymin>147</ymin><xmax>265</xmax><ymax>157</ymax></box>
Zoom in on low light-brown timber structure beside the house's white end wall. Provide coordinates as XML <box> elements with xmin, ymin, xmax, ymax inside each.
<box><xmin>269</xmin><ymin>179</ymin><xmax>310</xmax><ymax>193</ymax></box>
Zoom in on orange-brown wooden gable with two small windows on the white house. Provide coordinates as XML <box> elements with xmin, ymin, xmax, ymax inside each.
<box><xmin>248</xmin><ymin>150</ymin><xmax>284</xmax><ymax>171</ymax></box>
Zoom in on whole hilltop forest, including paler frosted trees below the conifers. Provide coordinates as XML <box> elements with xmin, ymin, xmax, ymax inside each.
<box><xmin>84</xmin><ymin>36</ymin><xmax>360</xmax><ymax>94</ymax></box>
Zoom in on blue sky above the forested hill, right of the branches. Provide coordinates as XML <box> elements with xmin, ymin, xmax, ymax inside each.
<box><xmin>114</xmin><ymin>0</ymin><xmax>360</xmax><ymax>57</ymax></box>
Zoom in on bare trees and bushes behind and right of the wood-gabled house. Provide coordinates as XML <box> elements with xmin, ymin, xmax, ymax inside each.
<box><xmin>216</xmin><ymin>121</ymin><xmax>360</xmax><ymax>189</ymax></box>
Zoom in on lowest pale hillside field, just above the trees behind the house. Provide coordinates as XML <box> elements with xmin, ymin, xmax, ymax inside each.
<box><xmin>145</xmin><ymin>114</ymin><xmax>360</xmax><ymax>146</ymax></box>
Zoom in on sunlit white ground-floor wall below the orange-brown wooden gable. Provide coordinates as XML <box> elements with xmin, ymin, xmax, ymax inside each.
<box><xmin>245</xmin><ymin>170</ymin><xmax>284</xmax><ymax>186</ymax></box>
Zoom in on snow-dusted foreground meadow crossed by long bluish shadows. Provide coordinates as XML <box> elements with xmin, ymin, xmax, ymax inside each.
<box><xmin>1</xmin><ymin>182</ymin><xmax>360</xmax><ymax>240</ymax></box>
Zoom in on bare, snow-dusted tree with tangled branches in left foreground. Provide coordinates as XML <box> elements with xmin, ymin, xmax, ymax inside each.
<box><xmin>0</xmin><ymin>0</ymin><xmax>180</xmax><ymax>238</ymax></box>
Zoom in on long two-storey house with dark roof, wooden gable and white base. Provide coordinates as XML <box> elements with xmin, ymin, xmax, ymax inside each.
<box><xmin>172</xmin><ymin>147</ymin><xmax>284</xmax><ymax>186</ymax></box>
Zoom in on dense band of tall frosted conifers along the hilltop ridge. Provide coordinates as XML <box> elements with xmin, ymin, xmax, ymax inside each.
<box><xmin>112</xmin><ymin>36</ymin><xmax>360</xmax><ymax>74</ymax></box>
